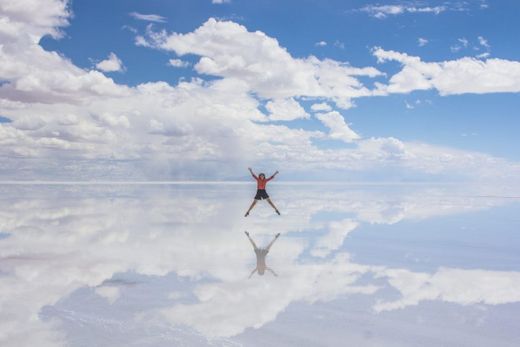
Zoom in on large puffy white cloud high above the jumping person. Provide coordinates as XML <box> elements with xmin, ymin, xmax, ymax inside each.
<box><xmin>140</xmin><ymin>18</ymin><xmax>382</xmax><ymax>108</ymax></box>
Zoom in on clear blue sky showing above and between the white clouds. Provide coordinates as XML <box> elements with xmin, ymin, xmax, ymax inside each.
<box><xmin>42</xmin><ymin>0</ymin><xmax>520</xmax><ymax>160</ymax></box>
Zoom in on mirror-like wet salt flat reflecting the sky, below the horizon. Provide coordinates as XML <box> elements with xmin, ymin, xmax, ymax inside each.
<box><xmin>0</xmin><ymin>183</ymin><xmax>520</xmax><ymax>346</ymax></box>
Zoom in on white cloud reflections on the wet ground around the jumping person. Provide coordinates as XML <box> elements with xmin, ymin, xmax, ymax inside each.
<box><xmin>0</xmin><ymin>185</ymin><xmax>520</xmax><ymax>346</ymax></box>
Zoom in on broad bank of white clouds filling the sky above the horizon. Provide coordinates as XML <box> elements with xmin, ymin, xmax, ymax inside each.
<box><xmin>0</xmin><ymin>0</ymin><xmax>520</xmax><ymax>180</ymax></box>
